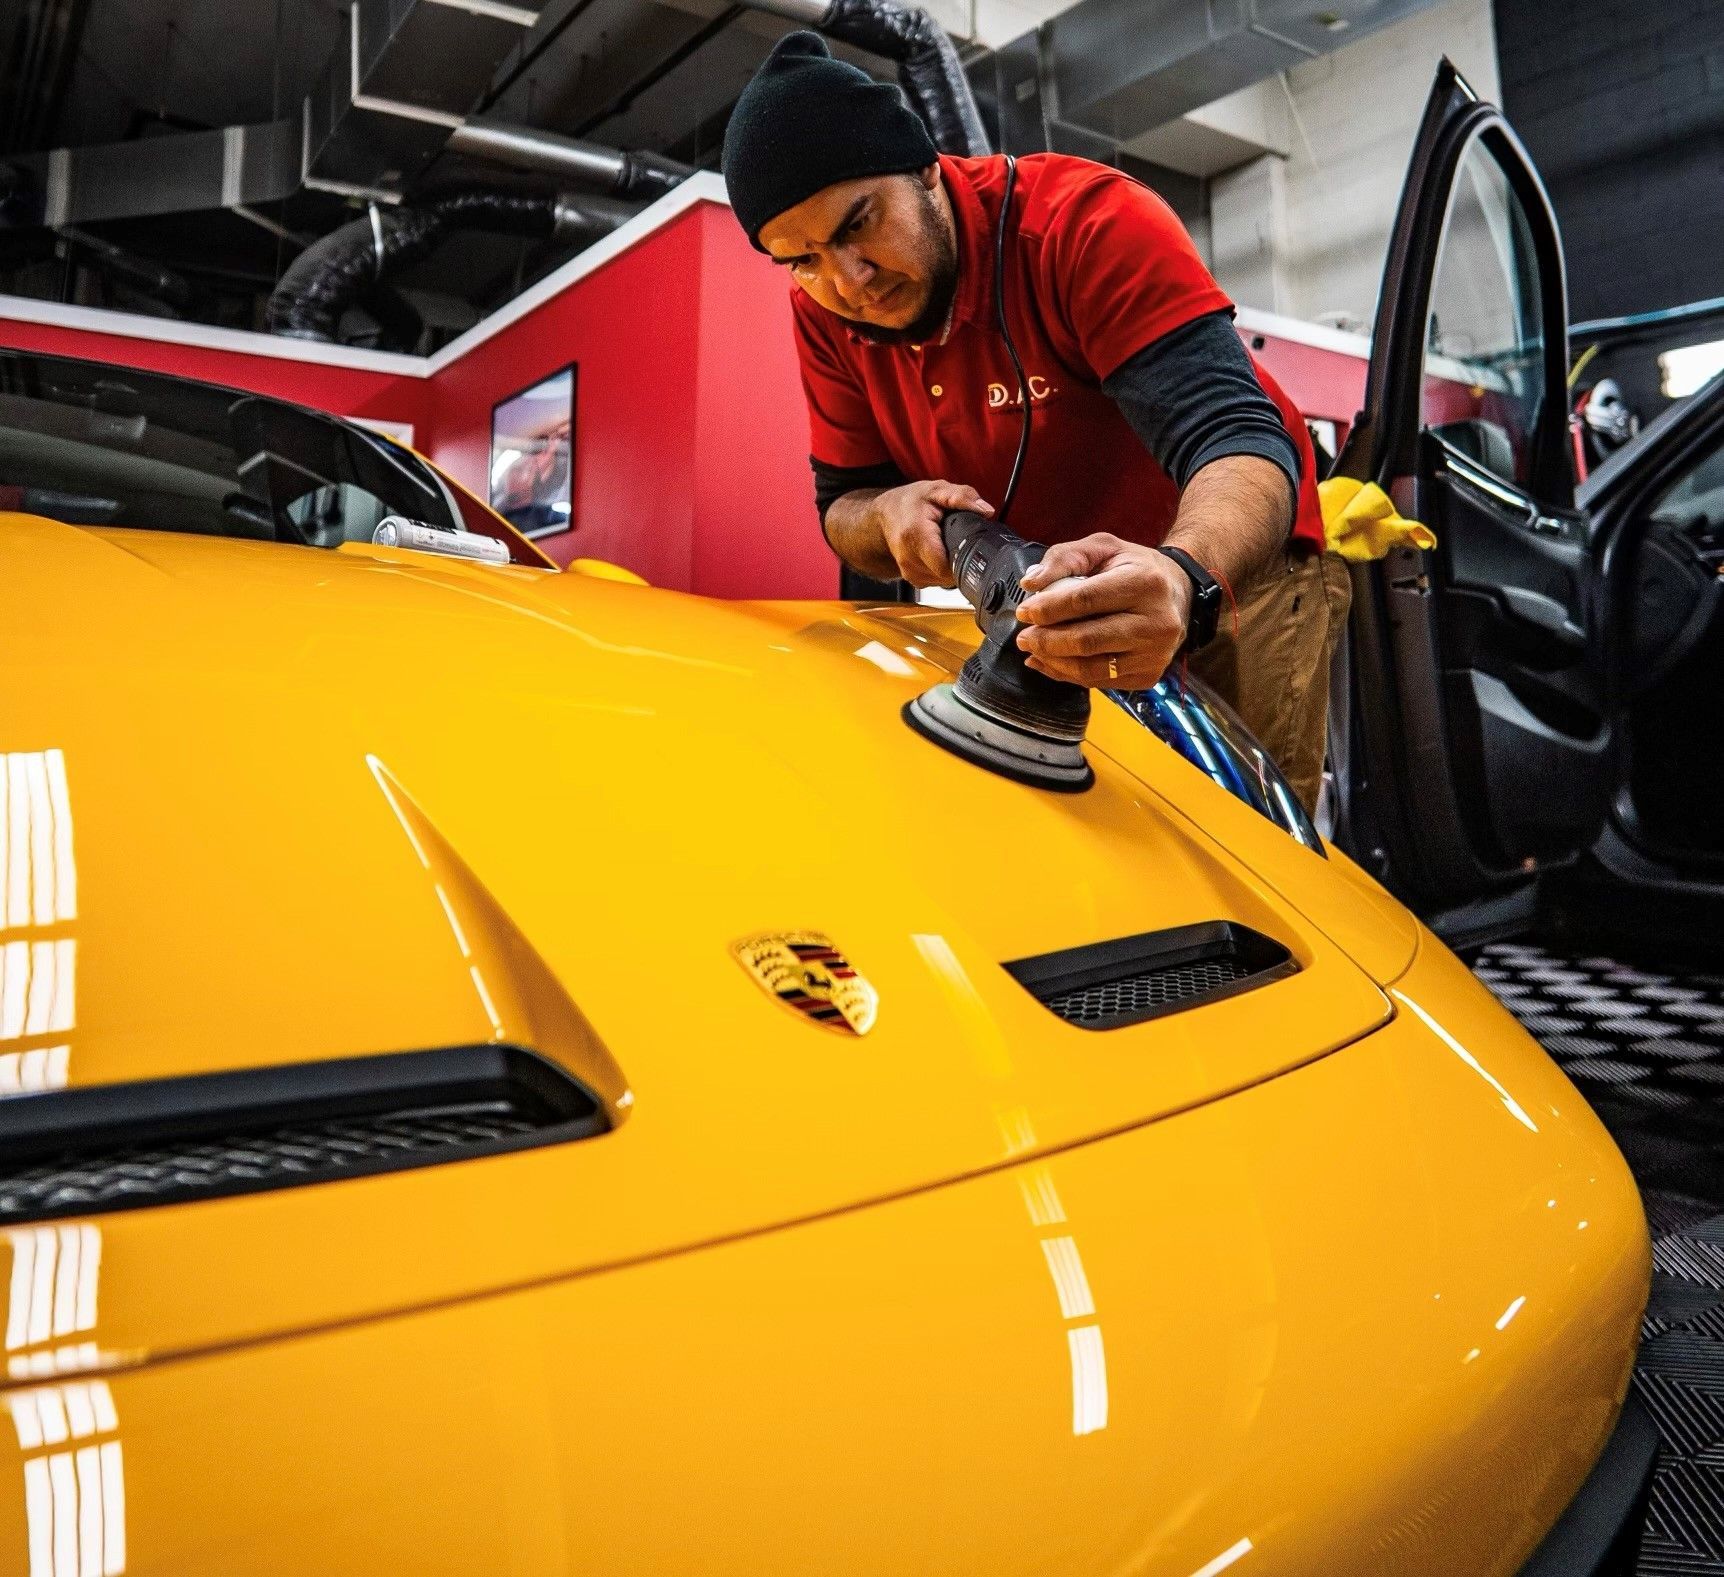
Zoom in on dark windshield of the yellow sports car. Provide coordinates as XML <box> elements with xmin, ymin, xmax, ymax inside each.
<box><xmin>0</xmin><ymin>352</ymin><xmax>541</xmax><ymax>564</ymax></box>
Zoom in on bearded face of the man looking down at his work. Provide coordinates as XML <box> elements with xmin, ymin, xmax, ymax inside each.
<box><xmin>760</xmin><ymin>164</ymin><xmax>957</xmax><ymax>341</ymax></box>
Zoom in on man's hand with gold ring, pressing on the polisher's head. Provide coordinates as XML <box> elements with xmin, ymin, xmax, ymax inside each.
<box><xmin>1017</xmin><ymin>531</ymin><xmax>1191</xmax><ymax>689</ymax></box>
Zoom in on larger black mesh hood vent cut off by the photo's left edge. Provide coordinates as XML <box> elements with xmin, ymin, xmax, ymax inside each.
<box><xmin>0</xmin><ymin>1046</ymin><xmax>610</xmax><ymax>1225</ymax></box>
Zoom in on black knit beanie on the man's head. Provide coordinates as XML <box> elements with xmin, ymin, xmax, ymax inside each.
<box><xmin>724</xmin><ymin>33</ymin><xmax>940</xmax><ymax>252</ymax></box>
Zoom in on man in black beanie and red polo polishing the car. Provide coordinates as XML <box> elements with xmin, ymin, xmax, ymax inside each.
<box><xmin>724</xmin><ymin>33</ymin><xmax>1348</xmax><ymax>807</ymax></box>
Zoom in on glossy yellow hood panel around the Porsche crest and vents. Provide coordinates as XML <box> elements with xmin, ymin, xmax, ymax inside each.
<box><xmin>0</xmin><ymin>515</ymin><xmax>1412</xmax><ymax>1355</ymax></box>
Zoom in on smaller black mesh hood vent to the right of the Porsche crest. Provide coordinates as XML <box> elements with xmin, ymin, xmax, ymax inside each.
<box><xmin>1005</xmin><ymin>920</ymin><xmax>1298</xmax><ymax>1029</ymax></box>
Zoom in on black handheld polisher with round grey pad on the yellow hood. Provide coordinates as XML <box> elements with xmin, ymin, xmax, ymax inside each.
<box><xmin>903</xmin><ymin>510</ymin><xmax>1095</xmax><ymax>795</ymax></box>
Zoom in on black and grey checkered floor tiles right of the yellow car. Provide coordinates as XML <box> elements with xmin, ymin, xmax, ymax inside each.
<box><xmin>1472</xmin><ymin>943</ymin><xmax>1724</xmax><ymax>1577</ymax></box>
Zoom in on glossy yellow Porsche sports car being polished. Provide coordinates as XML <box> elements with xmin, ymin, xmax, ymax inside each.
<box><xmin>0</xmin><ymin>332</ymin><xmax>1650</xmax><ymax>1577</ymax></box>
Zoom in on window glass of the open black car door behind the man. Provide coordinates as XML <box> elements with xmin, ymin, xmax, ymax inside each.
<box><xmin>1419</xmin><ymin>136</ymin><xmax>1548</xmax><ymax>486</ymax></box>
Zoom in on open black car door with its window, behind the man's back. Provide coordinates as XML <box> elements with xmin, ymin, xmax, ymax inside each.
<box><xmin>1334</xmin><ymin>60</ymin><xmax>1608</xmax><ymax>913</ymax></box>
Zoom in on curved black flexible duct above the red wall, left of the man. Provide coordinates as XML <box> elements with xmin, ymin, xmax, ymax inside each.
<box><xmin>265</xmin><ymin>191</ymin><xmax>631</xmax><ymax>343</ymax></box>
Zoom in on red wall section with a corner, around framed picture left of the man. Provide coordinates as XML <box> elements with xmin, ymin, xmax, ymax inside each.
<box><xmin>422</xmin><ymin>202</ymin><xmax>838</xmax><ymax>596</ymax></box>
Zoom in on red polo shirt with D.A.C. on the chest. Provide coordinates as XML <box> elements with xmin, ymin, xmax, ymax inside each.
<box><xmin>791</xmin><ymin>153</ymin><xmax>1324</xmax><ymax>548</ymax></box>
